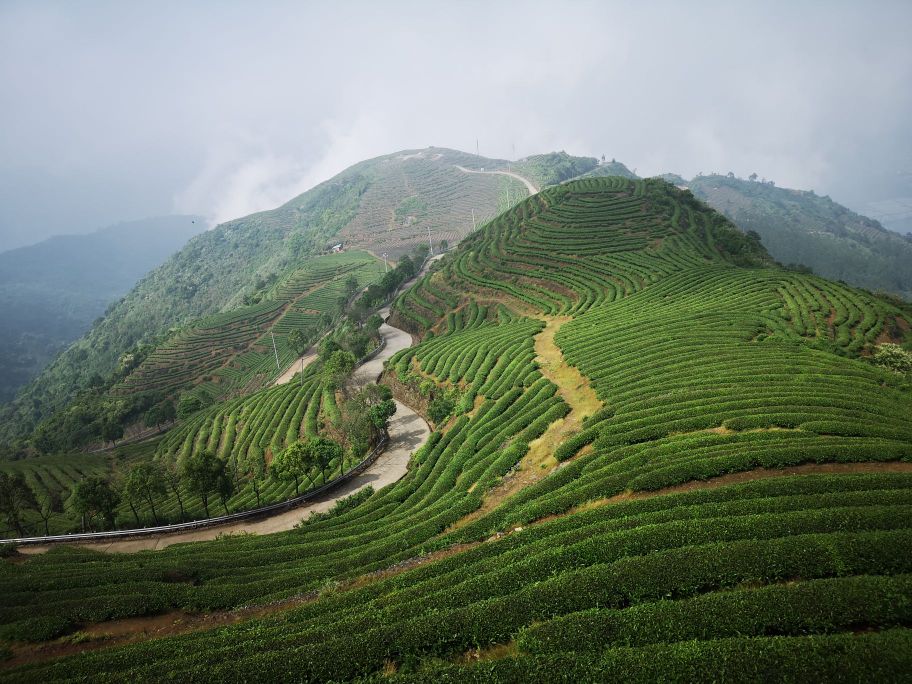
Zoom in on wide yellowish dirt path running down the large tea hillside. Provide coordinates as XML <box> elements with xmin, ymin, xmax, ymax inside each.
<box><xmin>451</xmin><ymin>316</ymin><xmax>602</xmax><ymax>529</ymax></box>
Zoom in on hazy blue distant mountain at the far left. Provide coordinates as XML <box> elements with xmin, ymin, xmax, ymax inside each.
<box><xmin>0</xmin><ymin>216</ymin><xmax>205</xmax><ymax>402</ymax></box>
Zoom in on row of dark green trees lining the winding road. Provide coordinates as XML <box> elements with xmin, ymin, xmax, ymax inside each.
<box><xmin>0</xmin><ymin>245</ymin><xmax>420</xmax><ymax>536</ymax></box>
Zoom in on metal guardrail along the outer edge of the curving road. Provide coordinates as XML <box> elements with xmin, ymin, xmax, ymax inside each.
<box><xmin>0</xmin><ymin>435</ymin><xmax>389</xmax><ymax>546</ymax></box>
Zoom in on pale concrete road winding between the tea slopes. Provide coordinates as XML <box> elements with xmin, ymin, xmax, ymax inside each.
<box><xmin>19</xmin><ymin>316</ymin><xmax>431</xmax><ymax>553</ymax></box>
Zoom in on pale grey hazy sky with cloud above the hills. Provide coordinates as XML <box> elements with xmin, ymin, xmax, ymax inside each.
<box><xmin>0</xmin><ymin>0</ymin><xmax>912</xmax><ymax>250</ymax></box>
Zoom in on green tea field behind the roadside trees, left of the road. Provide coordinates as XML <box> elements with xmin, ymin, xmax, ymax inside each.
<box><xmin>3</xmin><ymin>369</ymin><xmax>356</xmax><ymax>536</ymax></box>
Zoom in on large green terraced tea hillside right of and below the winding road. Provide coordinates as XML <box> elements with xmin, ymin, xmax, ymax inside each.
<box><xmin>0</xmin><ymin>176</ymin><xmax>912</xmax><ymax>682</ymax></box>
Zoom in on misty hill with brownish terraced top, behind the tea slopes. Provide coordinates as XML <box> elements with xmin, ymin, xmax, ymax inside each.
<box><xmin>0</xmin><ymin>148</ymin><xmax>552</xmax><ymax>442</ymax></box>
